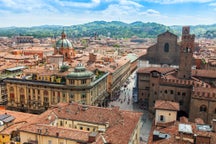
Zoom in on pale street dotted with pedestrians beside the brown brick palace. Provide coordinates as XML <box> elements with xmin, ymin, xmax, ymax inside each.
<box><xmin>109</xmin><ymin>72</ymin><xmax>152</xmax><ymax>142</ymax></box>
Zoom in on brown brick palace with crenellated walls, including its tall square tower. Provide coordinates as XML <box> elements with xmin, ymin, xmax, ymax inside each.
<box><xmin>137</xmin><ymin>27</ymin><xmax>216</xmax><ymax>123</ymax></box>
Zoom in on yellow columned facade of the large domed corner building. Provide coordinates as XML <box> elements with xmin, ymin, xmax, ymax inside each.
<box><xmin>6</xmin><ymin>71</ymin><xmax>107</xmax><ymax>110</ymax></box>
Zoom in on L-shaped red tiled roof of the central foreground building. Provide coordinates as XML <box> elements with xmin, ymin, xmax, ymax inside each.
<box><xmin>22</xmin><ymin>103</ymin><xmax>142</xmax><ymax>144</ymax></box>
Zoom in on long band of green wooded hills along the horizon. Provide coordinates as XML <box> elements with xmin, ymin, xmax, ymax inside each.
<box><xmin>0</xmin><ymin>21</ymin><xmax>216</xmax><ymax>38</ymax></box>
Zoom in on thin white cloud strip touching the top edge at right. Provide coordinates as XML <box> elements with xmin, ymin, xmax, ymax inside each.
<box><xmin>144</xmin><ymin>0</ymin><xmax>214</xmax><ymax>4</ymax></box>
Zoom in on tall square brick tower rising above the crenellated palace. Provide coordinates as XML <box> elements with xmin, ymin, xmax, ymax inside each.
<box><xmin>178</xmin><ymin>26</ymin><xmax>195</xmax><ymax>79</ymax></box>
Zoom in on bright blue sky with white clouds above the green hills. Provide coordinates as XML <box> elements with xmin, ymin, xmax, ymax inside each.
<box><xmin>0</xmin><ymin>0</ymin><xmax>216</xmax><ymax>27</ymax></box>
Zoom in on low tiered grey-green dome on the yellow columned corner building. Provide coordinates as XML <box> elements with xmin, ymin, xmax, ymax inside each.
<box><xmin>67</xmin><ymin>64</ymin><xmax>94</xmax><ymax>79</ymax></box>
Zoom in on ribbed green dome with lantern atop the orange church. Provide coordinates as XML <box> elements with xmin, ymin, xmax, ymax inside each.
<box><xmin>55</xmin><ymin>31</ymin><xmax>73</xmax><ymax>49</ymax></box>
